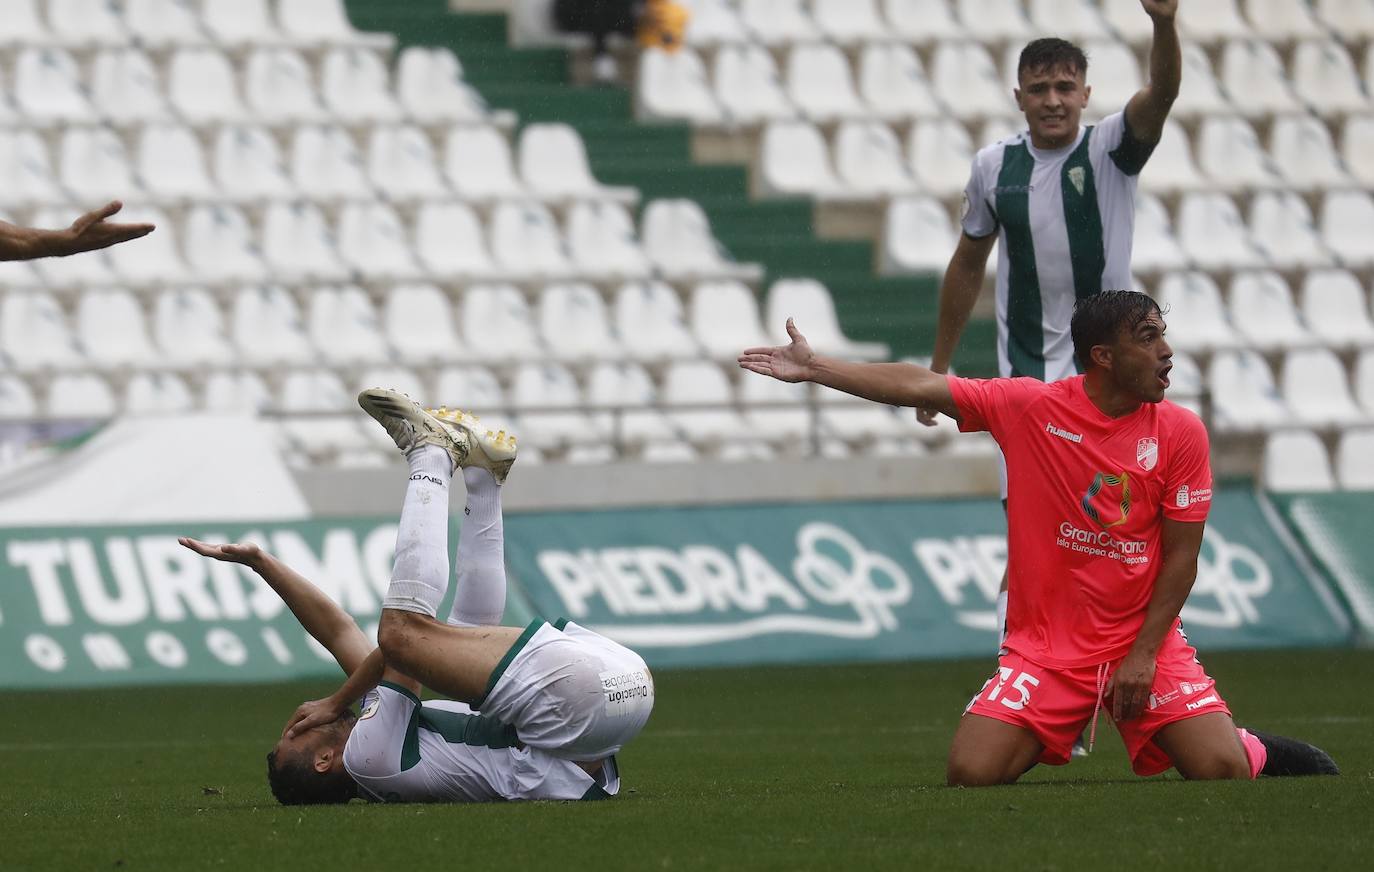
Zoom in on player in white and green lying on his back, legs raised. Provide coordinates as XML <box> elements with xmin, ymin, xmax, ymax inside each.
<box><xmin>181</xmin><ymin>389</ymin><xmax>654</xmax><ymax>805</ymax></box>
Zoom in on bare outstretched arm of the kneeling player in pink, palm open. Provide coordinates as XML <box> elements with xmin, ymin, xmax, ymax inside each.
<box><xmin>739</xmin><ymin>319</ymin><xmax>959</xmax><ymax>420</ymax></box>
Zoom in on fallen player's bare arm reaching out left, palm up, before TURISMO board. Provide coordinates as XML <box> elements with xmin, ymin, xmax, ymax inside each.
<box><xmin>177</xmin><ymin>536</ymin><xmax>375</xmax><ymax>675</ymax></box>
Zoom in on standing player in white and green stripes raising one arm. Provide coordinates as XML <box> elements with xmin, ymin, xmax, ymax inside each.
<box><xmin>916</xmin><ymin>0</ymin><xmax>1183</xmax><ymax>653</ymax></box>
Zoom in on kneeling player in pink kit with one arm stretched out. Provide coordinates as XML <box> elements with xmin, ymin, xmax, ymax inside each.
<box><xmin>739</xmin><ymin>291</ymin><xmax>1337</xmax><ymax>787</ymax></box>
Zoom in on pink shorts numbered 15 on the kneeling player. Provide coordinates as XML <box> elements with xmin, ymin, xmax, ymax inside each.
<box><xmin>965</xmin><ymin>628</ymin><xmax>1231</xmax><ymax>776</ymax></box>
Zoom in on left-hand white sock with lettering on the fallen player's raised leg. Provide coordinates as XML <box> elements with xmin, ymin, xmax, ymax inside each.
<box><xmin>382</xmin><ymin>445</ymin><xmax>453</xmax><ymax>618</ymax></box>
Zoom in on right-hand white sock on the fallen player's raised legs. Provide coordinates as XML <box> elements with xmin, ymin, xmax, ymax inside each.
<box><xmin>448</xmin><ymin>467</ymin><xmax>506</xmax><ymax>626</ymax></box>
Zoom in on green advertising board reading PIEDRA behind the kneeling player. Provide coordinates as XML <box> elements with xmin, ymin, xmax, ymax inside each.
<box><xmin>506</xmin><ymin>492</ymin><xmax>1349</xmax><ymax>666</ymax></box>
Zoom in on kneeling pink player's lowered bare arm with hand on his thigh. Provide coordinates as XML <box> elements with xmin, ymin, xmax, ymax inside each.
<box><xmin>1106</xmin><ymin>518</ymin><xmax>1206</xmax><ymax>721</ymax></box>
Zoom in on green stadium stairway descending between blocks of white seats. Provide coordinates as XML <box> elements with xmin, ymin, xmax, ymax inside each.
<box><xmin>346</xmin><ymin>0</ymin><xmax>996</xmax><ymax>376</ymax></box>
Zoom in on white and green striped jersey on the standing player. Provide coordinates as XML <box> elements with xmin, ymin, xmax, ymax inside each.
<box><xmin>963</xmin><ymin>113</ymin><xmax>1154</xmax><ymax>382</ymax></box>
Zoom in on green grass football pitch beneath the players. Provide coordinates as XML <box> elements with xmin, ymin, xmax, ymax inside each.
<box><xmin>0</xmin><ymin>651</ymin><xmax>1374</xmax><ymax>872</ymax></box>
